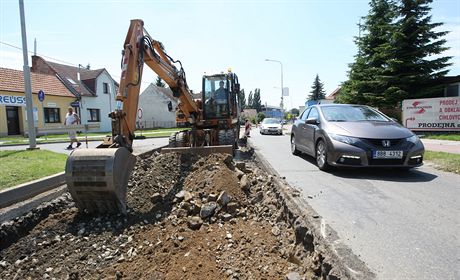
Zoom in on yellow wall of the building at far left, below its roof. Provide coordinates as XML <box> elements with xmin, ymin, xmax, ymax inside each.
<box><xmin>0</xmin><ymin>91</ymin><xmax>75</xmax><ymax>136</ymax></box>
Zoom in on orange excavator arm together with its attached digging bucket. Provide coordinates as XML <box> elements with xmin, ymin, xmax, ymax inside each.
<box><xmin>65</xmin><ymin>20</ymin><xmax>201</xmax><ymax>213</ymax></box>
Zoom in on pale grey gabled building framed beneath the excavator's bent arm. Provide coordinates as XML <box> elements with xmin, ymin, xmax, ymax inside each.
<box><xmin>137</xmin><ymin>84</ymin><xmax>178</xmax><ymax>128</ymax></box>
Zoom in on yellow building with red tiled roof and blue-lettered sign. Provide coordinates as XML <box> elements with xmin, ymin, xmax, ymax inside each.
<box><xmin>0</xmin><ymin>68</ymin><xmax>76</xmax><ymax>136</ymax></box>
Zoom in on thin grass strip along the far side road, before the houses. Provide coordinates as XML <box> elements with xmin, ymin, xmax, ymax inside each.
<box><xmin>0</xmin><ymin>128</ymin><xmax>183</xmax><ymax>145</ymax></box>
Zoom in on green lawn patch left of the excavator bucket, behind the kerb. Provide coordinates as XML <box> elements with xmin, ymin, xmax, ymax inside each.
<box><xmin>0</xmin><ymin>150</ymin><xmax>67</xmax><ymax>190</ymax></box>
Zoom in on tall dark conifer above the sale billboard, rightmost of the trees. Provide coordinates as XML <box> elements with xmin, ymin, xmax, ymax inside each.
<box><xmin>388</xmin><ymin>0</ymin><xmax>452</xmax><ymax>102</ymax></box>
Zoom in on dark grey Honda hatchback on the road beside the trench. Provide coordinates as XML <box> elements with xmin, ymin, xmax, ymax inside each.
<box><xmin>291</xmin><ymin>104</ymin><xmax>425</xmax><ymax>170</ymax></box>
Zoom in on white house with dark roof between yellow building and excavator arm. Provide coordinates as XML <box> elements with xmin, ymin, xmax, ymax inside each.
<box><xmin>31</xmin><ymin>55</ymin><xmax>118</xmax><ymax>131</ymax></box>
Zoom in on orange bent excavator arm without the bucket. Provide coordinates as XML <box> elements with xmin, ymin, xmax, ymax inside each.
<box><xmin>111</xmin><ymin>19</ymin><xmax>200</xmax><ymax>148</ymax></box>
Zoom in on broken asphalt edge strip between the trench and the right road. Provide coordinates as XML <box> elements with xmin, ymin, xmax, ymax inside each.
<box><xmin>250</xmin><ymin>143</ymin><xmax>376</xmax><ymax>280</ymax></box>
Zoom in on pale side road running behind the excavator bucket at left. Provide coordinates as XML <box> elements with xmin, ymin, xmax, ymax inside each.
<box><xmin>0</xmin><ymin>137</ymin><xmax>168</xmax><ymax>155</ymax></box>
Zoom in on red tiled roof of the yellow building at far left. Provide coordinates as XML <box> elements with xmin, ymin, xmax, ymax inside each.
<box><xmin>0</xmin><ymin>67</ymin><xmax>75</xmax><ymax>98</ymax></box>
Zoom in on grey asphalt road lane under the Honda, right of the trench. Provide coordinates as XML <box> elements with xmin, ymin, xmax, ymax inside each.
<box><xmin>249</xmin><ymin>129</ymin><xmax>460</xmax><ymax>279</ymax></box>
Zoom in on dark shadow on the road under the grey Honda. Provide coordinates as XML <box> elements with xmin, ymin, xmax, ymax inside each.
<box><xmin>300</xmin><ymin>154</ymin><xmax>438</xmax><ymax>182</ymax></box>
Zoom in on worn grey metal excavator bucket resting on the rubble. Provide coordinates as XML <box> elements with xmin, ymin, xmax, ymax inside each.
<box><xmin>65</xmin><ymin>148</ymin><xmax>136</xmax><ymax>214</ymax></box>
